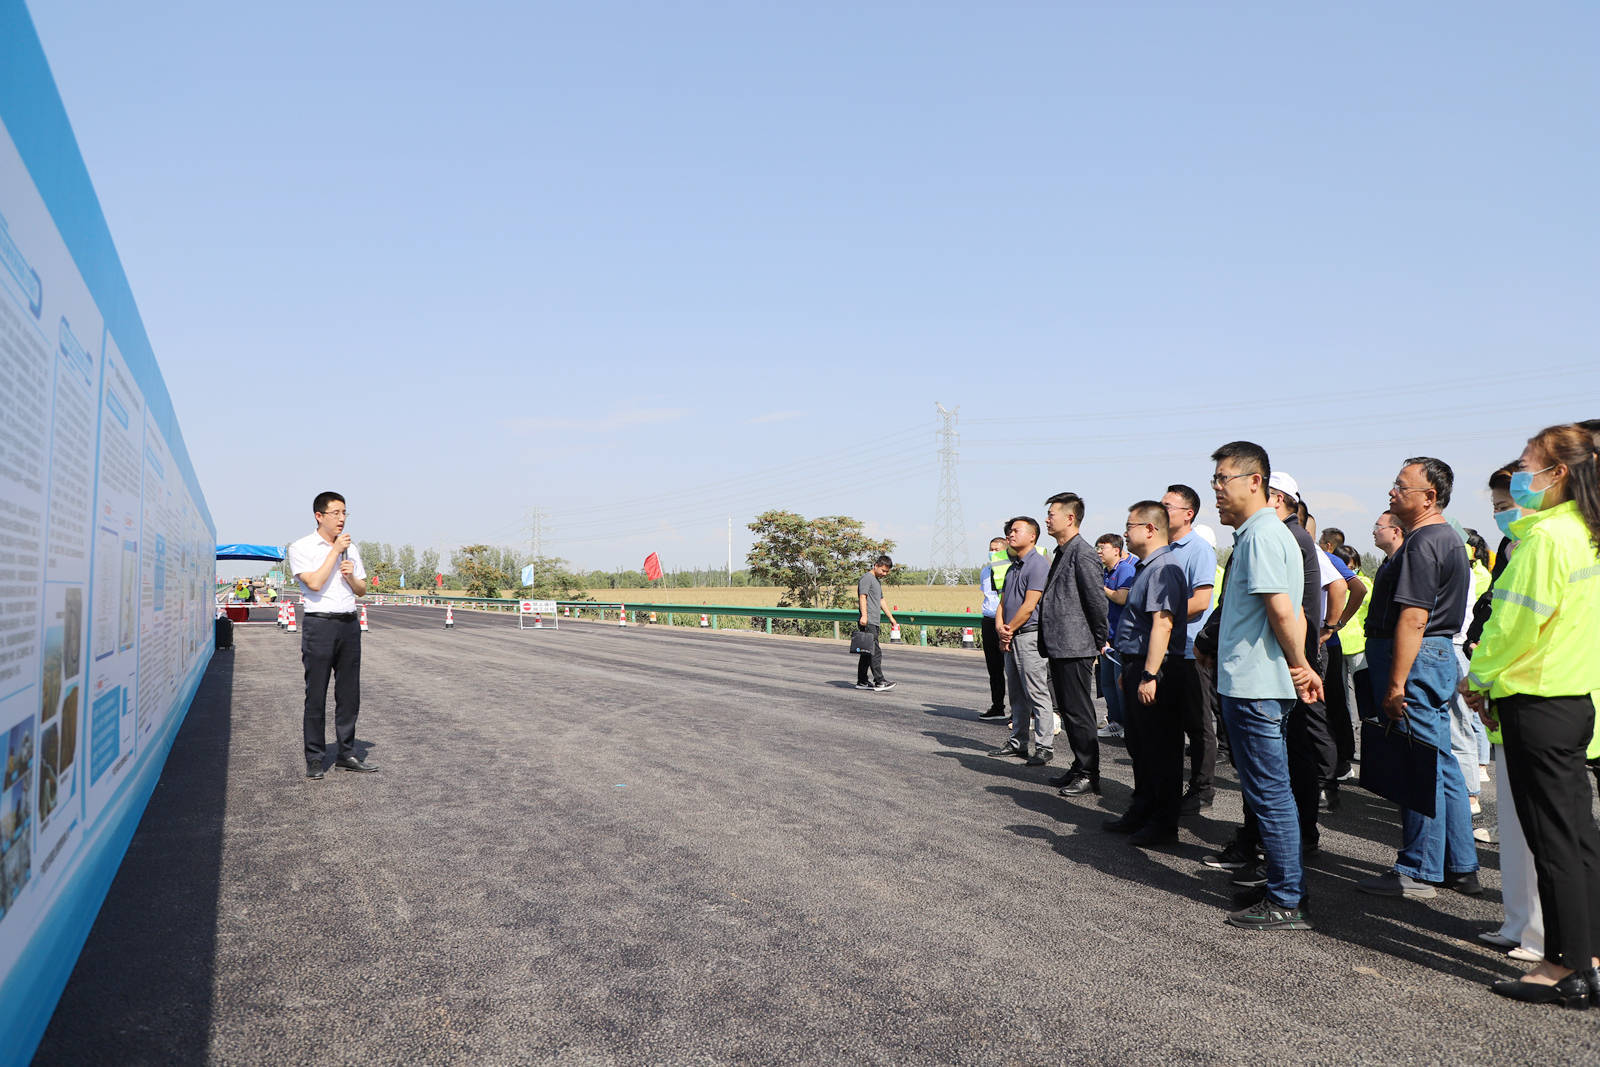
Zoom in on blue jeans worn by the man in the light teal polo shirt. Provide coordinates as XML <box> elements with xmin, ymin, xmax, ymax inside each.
<box><xmin>1221</xmin><ymin>696</ymin><xmax>1305</xmax><ymax>907</ymax></box>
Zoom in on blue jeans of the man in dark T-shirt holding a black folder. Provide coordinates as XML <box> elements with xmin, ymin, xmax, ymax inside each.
<box><xmin>1366</xmin><ymin>637</ymin><xmax>1478</xmax><ymax>881</ymax></box>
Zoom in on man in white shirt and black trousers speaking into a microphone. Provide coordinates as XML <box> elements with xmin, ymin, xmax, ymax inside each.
<box><xmin>290</xmin><ymin>493</ymin><xmax>378</xmax><ymax>779</ymax></box>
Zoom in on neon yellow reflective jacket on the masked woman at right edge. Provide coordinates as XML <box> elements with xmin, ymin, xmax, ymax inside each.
<box><xmin>1467</xmin><ymin>501</ymin><xmax>1600</xmax><ymax>755</ymax></box>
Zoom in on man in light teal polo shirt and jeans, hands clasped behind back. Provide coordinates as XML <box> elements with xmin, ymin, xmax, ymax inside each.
<box><xmin>1211</xmin><ymin>442</ymin><xmax>1322</xmax><ymax>929</ymax></box>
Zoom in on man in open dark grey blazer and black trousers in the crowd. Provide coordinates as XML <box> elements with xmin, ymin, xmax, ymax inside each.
<box><xmin>1038</xmin><ymin>493</ymin><xmax>1109</xmax><ymax>797</ymax></box>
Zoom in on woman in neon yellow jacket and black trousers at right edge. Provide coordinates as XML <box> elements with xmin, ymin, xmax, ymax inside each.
<box><xmin>1461</xmin><ymin>426</ymin><xmax>1600</xmax><ymax>1008</ymax></box>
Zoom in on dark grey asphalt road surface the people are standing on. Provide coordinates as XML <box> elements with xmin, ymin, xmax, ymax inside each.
<box><xmin>28</xmin><ymin>606</ymin><xmax>1600</xmax><ymax>1064</ymax></box>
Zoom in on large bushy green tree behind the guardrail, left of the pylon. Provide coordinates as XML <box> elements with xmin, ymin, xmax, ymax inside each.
<box><xmin>746</xmin><ymin>510</ymin><xmax>894</xmax><ymax>608</ymax></box>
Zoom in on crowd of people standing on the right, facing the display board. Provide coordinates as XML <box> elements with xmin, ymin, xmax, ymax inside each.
<box><xmin>934</xmin><ymin>421</ymin><xmax>1600</xmax><ymax>1008</ymax></box>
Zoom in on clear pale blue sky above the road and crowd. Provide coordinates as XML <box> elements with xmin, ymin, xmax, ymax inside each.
<box><xmin>32</xmin><ymin>0</ymin><xmax>1600</xmax><ymax>569</ymax></box>
